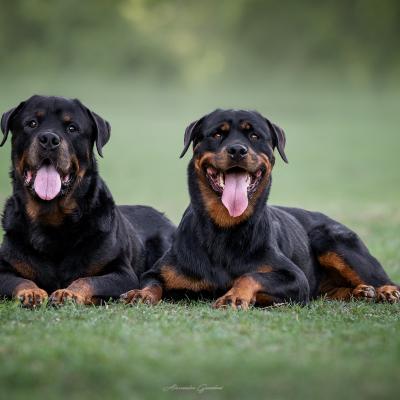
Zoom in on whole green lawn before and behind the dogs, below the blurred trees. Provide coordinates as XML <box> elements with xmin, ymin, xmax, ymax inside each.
<box><xmin>0</xmin><ymin>76</ymin><xmax>400</xmax><ymax>400</ymax></box>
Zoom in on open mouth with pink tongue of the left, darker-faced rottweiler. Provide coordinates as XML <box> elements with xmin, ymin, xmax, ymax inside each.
<box><xmin>24</xmin><ymin>159</ymin><xmax>74</xmax><ymax>201</ymax></box>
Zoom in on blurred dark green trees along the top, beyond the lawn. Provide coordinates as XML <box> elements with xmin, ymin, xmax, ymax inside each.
<box><xmin>0</xmin><ymin>0</ymin><xmax>400</xmax><ymax>82</ymax></box>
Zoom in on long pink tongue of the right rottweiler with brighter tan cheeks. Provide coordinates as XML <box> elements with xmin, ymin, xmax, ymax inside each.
<box><xmin>222</xmin><ymin>172</ymin><xmax>250</xmax><ymax>217</ymax></box>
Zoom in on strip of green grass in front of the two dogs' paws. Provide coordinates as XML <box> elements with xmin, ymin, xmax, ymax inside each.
<box><xmin>0</xmin><ymin>301</ymin><xmax>400</xmax><ymax>399</ymax></box>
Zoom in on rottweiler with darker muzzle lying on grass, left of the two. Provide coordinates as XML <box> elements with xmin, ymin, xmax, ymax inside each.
<box><xmin>0</xmin><ymin>96</ymin><xmax>175</xmax><ymax>308</ymax></box>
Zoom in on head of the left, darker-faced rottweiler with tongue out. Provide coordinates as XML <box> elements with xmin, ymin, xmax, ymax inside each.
<box><xmin>0</xmin><ymin>96</ymin><xmax>110</xmax><ymax>202</ymax></box>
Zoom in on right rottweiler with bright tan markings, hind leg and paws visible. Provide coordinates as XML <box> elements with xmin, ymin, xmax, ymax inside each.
<box><xmin>122</xmin><ymin>110</ymin><xmax>400</xmax><ymax>309</ymax></box>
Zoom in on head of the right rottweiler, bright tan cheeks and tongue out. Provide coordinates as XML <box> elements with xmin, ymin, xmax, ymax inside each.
<box><xmin>181</xmin><ymin>110</ymin><xmax>287</xmax><ymax>228</ymax></box>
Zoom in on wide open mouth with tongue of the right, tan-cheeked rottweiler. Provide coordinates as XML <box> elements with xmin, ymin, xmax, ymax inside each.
<box><xmin>205</xmin><ymin>166</ymin><xmax>265</xmax><ymax>217</ymax></box>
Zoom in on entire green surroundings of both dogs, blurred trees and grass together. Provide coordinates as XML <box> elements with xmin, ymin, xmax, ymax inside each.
<box><xmin>0</xmin><ymin>0</ymin><xmax>400</xmax><ymax>399</ymax></box>
